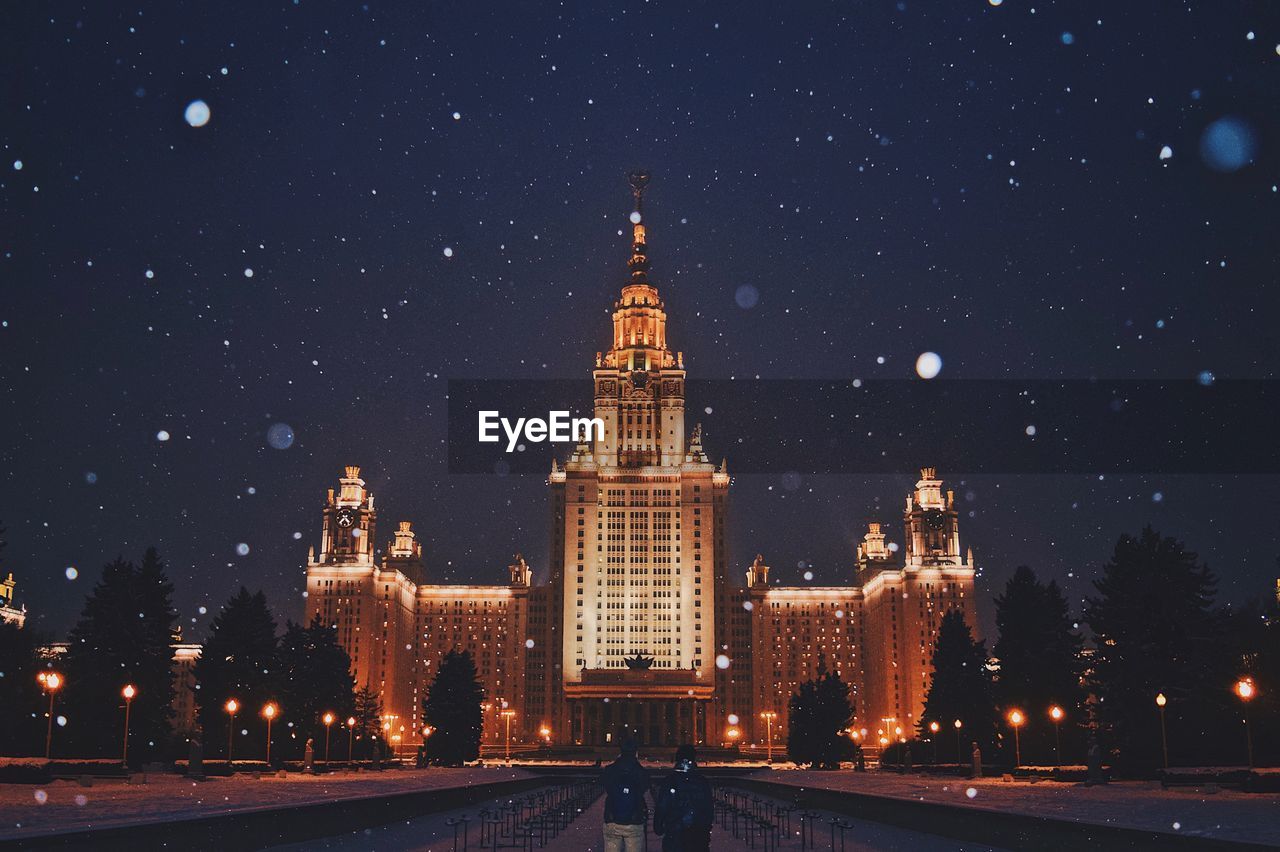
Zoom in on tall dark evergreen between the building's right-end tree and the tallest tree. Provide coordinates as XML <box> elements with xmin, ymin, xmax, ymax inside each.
<box><xmin>992</xmin><ymin>565</ymin><xmax>1085</xmax><ymax>762</ymax></box>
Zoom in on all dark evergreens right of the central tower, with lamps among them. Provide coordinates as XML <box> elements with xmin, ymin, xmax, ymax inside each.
<box><xmin>787</xmin><ymin>527</ymin><xmax>1280</xmax><ymax>775</ymax></box>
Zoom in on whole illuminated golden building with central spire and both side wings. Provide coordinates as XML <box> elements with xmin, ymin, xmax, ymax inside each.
<box><xmin>307</xmin><ymin>173</ymin><xmax>975</xmax><ymax>745</ymax></box>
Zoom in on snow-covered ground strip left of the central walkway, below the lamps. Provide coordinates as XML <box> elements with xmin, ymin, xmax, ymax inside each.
<box><xmin>0</xmin><ymin>766</ymin><xmax>529</xmax><ymax>840</ymax></box>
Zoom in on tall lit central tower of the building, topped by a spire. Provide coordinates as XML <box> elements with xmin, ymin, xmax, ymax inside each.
<box><xmin>549</xmin><ymin>171</ymin><xmax>730</xmax><ymax>745</ymax></box>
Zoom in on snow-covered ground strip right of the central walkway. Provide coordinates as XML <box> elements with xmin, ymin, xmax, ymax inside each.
<box><xmin>753</xmin><ymin>771</ymin><xmax>1280</xmax><ymax>846</ymax></box>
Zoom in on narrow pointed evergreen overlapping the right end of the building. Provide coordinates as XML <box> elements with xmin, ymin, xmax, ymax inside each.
<box><xmin>918</xmin><ymin>609</ymin><xmax>996</xmax><ymax>762</ymax></box>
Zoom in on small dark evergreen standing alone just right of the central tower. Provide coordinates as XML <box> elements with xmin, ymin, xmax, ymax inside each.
<box><xmin>787</xmin><ymin>655</ymin><xmax>854</xmax><ymax>769</ymax></box>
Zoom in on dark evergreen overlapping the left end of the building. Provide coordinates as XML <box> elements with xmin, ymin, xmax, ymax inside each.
<box><xmin>279</xmin><ymin>617</ymin><xmax>356</xmax><ymax>753</ymax></box>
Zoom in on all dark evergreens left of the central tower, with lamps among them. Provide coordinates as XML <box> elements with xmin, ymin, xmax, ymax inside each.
<box><xmin>0</xmin><ymin>528</ymin><xmax>484</xmax><ymax>766</ymax></box>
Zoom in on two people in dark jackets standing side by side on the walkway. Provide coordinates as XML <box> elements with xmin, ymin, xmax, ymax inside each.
<box><xmin>602</xmin><ymin>739</ymin><xmax>716</xmax><ymax>852</ymax></box>
